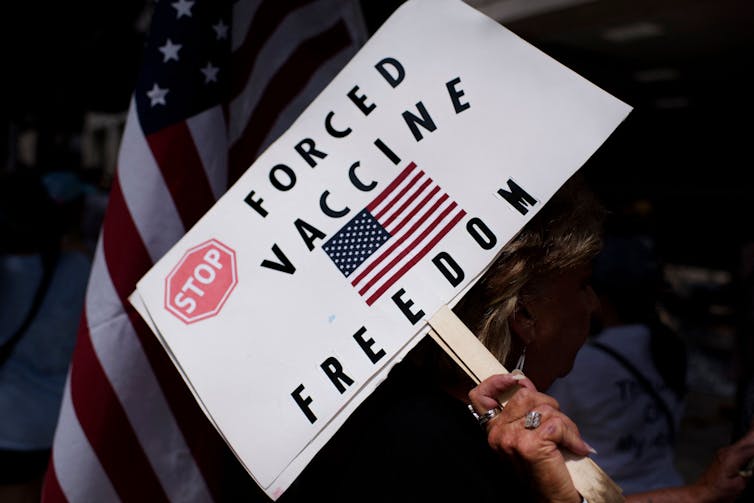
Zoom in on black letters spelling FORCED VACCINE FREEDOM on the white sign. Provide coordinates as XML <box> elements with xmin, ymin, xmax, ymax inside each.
<box><xmin>238</xmin><ymin>57</ymin><xmax>538</xmax><ymax>423</ymax></box>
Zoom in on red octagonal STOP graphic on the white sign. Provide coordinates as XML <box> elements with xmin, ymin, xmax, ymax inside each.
<box><xmin>165</xmin><ymin>239</ymin><xmax>238</xmax><ymax>323</ymax></box>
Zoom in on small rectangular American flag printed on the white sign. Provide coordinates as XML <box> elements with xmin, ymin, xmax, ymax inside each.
<box><xmin>322</xmin><ymin>162</ymin><xmax>466</xmax><ymax>306</ymax></box>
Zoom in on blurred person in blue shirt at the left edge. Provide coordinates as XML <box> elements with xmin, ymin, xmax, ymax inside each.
<box><xmin>0</xmin><ymin>172</ymin><xmax>91</xmax><ymax>503</ymax></box>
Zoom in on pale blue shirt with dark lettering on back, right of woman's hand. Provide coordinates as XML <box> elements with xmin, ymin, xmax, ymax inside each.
<box><xmin>548</xmin><ymin>325</ymin><xmax>683</xmax><ymax>494</ymax></box>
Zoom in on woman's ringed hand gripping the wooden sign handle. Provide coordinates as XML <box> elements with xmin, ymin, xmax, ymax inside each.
<box><xmin>469</xmin><ymin>374</ymin><xmax>593</xmax><ymax>503</ymax></box>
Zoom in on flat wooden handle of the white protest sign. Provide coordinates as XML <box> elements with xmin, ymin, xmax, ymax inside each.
<box><xmin>428</xmin><ymin>306</ymin><xmax>625</xmax><ymax>503</ymax></box>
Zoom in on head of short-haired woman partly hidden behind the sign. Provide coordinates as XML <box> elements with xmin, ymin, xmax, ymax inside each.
<box><xmin>456</xmin><ymin>177</ymin><xmax>604</xmax><ymax>387</ymax></box>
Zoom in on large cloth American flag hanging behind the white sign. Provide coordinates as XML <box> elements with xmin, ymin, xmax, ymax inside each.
<box><xmin>43</xmin><ymin>0</ymin><xmax>366</xmax><ymax>502</ymax></box>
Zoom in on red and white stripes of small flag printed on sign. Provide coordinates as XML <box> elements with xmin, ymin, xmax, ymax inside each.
<box><xmin>351</xmin><ymin>162</ymin><xmax>466</xmax><ymax>306</ymax></box>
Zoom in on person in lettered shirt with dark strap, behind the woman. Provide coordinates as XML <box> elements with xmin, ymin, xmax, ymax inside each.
<box><xmin>548</xmin><ymin>234</ymin><xmax>687</xmax><ymax>493</ymax></box>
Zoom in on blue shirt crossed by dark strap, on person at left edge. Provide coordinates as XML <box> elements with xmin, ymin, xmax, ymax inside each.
<box><xmin>0</xmin><ymin>252</ymin><xmax>91</xmax><ymax>450</ymax></box>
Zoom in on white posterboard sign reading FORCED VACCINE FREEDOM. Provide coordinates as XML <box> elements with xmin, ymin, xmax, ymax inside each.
<box><xmin>131</xmin><ymin>0</ymin><xmax>630</xmax><ymax>499</ymax></box>
